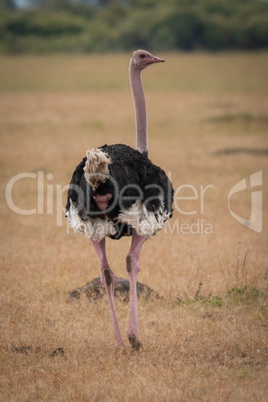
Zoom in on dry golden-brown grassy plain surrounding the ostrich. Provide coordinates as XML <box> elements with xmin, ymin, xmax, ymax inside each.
<box><xmin>0</xmin><ymin>53</ymin><xmax>268</xmax><ymax>401</ymax></box>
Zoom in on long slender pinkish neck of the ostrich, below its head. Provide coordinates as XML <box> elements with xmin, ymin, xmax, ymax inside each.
<box><xmin>129</xmin><ymin>62</ymin><xmax>148</xmax><ymax>155</ymax></box>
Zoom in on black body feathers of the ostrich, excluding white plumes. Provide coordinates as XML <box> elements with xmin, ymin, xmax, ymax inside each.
<box><xmin>66</xmin><ymin>144</ymin><xmax>173</xmax><ymax>239</ymax></box>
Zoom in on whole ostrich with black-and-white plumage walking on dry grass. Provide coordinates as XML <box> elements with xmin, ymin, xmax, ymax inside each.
<box><xmin>66</xmin><ymin>50</ymin><xmax>173</xmax><ymax>350</ymax></box>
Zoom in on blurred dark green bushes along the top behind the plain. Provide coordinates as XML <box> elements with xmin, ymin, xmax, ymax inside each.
<box><xmin>0</xmin><ymin>0</ymin><xmax>268</xmax><ymax>53</ymax></box>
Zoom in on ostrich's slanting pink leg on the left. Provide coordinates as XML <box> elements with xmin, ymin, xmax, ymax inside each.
<box><xmin>91</xmin><ymin>238</ymin><xmax>125</xmax><ymax>349</ymax></box>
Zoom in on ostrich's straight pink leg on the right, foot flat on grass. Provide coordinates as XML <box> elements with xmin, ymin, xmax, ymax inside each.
<box><xmin>127</xmin><ymin>229</ymin><xmax>147</xmax><ymax>350</ymax></box>
